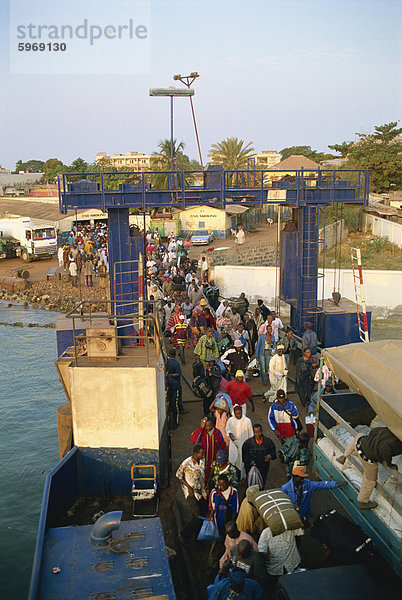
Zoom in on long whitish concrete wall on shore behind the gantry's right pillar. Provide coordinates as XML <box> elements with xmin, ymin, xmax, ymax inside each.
<box><xmin>214</xmin><ymin>265</ymin><xmax>402</xmax><ymax>317</ymax></box>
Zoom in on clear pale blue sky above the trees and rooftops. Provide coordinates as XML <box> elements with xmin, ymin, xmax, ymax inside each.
<box><xmin>0</xmin><ymin>0</ymin><xmax>402</xmax><ymax>169</ymax></box>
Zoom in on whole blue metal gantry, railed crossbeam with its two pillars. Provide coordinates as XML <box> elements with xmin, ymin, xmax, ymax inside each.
<box><xmin>59</xmin><ymin>166</ymin><xmax>369</xmax><ymax>334</ymax></box>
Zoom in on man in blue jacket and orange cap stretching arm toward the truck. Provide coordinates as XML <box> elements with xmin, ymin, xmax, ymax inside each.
<box><xmin>282</xmin><ymin>466</ymin><xmax>346</xmax><ymax>525</ymax></box>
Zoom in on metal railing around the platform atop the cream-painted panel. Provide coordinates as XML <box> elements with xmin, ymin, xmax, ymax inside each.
<box><xmin>60</xmin><ymin>300</ymin><xmax>166</xmax><ymax>367</ymax></box>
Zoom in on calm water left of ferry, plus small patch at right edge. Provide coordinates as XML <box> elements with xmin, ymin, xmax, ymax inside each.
<box><xmin>0</xmin><ymin>303</ymin><xmax>402</xmax><ymax>600</ymax></box>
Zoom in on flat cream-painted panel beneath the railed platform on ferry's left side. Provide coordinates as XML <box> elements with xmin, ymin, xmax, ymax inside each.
<box><xmin>69</xmin><ymin>365</ymin><xmax>162</xmax><ymax>450</ymax></box>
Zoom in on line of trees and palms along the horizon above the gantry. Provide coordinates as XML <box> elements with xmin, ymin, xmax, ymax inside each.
<box><xmin>14</xmin><ymin>121</ymin><xmax>402</xmax><ymax>192</ymax></box>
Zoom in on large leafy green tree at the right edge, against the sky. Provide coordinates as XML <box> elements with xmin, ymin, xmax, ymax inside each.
<box><xmin>342</xmin><ymin>121</ymin><xmax>402</xmax><ymax>192</ymax></box>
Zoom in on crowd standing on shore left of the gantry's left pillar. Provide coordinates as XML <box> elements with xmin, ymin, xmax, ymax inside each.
<box><xmin>57</xmin><ymin>223</ymin><xmax>109</xmax><ymax>288</ymax></box>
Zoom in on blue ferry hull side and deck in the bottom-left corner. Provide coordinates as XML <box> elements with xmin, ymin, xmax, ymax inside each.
<box><xmin>29</xmin><ymin>446</ymin><xmax>176</xmax><ymax>600</ymax></box>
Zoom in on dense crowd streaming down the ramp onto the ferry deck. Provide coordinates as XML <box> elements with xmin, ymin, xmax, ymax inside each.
<box><xmin>139</xmin><ymin>231</ymin><xmax>358</xmax><ymax>599</ymax></box>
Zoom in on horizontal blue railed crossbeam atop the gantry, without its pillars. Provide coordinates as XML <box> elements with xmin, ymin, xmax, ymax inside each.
<box><xmin>60</xmin><ymin>170</ymin><xmax>368</xmax><ymax>212</ymax></box>
